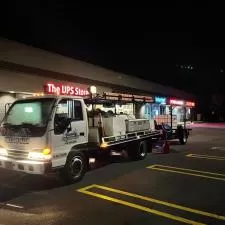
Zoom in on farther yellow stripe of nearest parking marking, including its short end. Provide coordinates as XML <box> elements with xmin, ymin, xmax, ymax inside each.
<box><xmin>77</xmin><ymin>184</ymin><xmax>225</xmax><ymax>220</ymax></box>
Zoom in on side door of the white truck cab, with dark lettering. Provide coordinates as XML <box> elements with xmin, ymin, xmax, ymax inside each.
<box><xmin>51</xmin><ymin>99</ymin><xmax>88</xmax><ymax>166</ymax></box>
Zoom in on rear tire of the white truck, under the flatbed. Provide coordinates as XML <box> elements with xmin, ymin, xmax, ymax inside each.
<box><xmin>127</xmin><ymin>141</ymin><xmax>148</xmax><ymax>161</ymax></box>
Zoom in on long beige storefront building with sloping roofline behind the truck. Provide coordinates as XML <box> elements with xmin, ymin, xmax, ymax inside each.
<box><xmin>0</xmin><ymin>39</ymin><xmax>194</xmax><ymax>123</ymax></box>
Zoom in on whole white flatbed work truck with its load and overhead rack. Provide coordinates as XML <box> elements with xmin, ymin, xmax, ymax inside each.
<box><xmin>0</xmin><ymin>89</ymin><xmax>161</xmax><ymax>183</ymax></box>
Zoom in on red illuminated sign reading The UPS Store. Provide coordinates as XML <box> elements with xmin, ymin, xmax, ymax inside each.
<box><xmin>44</xmin><ymin>83</ymin><xmax>89</xmax><ymax>96</ymax></box>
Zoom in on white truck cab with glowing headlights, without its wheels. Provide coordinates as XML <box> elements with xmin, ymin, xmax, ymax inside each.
<box><xmin>0</xmin><ymin>96</ymin><xmax>88</xmax><ymax>179</ymax></box>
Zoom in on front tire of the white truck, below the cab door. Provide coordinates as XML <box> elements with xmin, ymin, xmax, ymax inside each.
<box><xmin>60</xmin><ymin>151</ymin><xmax>88</xmax><ymax>184</ymax></box>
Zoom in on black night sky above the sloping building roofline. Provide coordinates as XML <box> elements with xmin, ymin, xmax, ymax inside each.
<box><xmin>2</xmin><ymin>4</ymin><xmax>225</xmax><ymax>98</ymax></box>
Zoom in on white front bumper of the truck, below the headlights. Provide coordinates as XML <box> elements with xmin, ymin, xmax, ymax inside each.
<box><xmin>0</xmin><ymin>156</ymin><xmax>52</xmax><ymax>175</ymax></box>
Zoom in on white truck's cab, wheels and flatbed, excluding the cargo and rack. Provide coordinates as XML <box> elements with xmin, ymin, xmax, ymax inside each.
<box><xmin>0</xmin><ymin>92</ymin><xmax>162</xmax><ymax>183</ymax></box>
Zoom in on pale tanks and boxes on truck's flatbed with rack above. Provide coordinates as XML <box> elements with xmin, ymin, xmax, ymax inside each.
<box><xmin>84</xmin><ymin>92</ymin><xmax>156</xmax><ymax>146</ymax></box>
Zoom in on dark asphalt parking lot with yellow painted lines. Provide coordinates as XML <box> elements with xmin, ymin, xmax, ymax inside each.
<box><xmin>0</xmin><ymin>127</ymin><xmax>225</xmax><ymax>225</ymax></box>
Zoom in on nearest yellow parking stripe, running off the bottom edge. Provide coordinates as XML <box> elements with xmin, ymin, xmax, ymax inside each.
<box><xmin>77</xmin><ymin>185</ymin><xmax>206</xmax><ymax>225</ymax></box>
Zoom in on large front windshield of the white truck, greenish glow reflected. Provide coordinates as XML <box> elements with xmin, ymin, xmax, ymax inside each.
<box><xmin>2</xmin><ymin>98</ymin><xmax>55</xmax><ymax>137</ymax></box>
